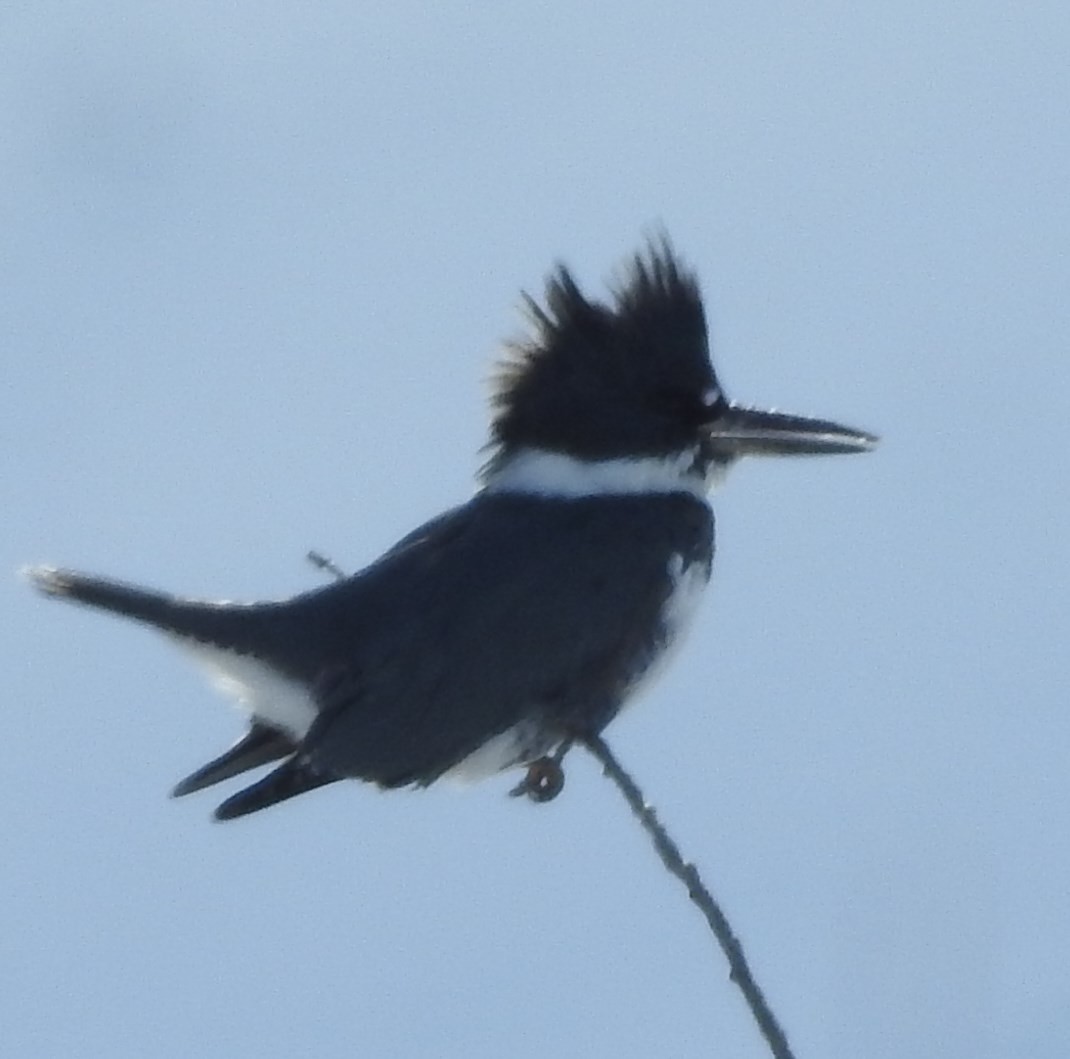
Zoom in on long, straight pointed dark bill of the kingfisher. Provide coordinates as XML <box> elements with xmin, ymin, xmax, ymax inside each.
<box><xmin>709</xmin><ymin>404</ymin><xmax>878</xmax><ymax>457</ymax></box>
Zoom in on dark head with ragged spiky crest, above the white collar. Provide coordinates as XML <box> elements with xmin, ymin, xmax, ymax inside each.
<box><xmin>490</xmin><ymin>239</ymin><xmax>717</xmax><ymax>470</ymax></box>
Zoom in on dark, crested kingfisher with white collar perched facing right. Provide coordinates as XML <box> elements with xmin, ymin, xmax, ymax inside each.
<box><xmin>29</xmin><ymin>239</ymin><xmax>876</xmax><ymax>819</ymax></box>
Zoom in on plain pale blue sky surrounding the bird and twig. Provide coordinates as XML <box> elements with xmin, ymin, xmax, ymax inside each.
<box><xmin>0</xmin><ymin>0</ymin><xmax>1070</xmax><ymax>1059</ymax></box>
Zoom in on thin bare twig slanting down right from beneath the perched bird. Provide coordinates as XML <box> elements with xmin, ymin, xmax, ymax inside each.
<box><xmin>584</xmin><ymin>736</ymin><xmax>794</xmax><ymax>1059</ymax></box>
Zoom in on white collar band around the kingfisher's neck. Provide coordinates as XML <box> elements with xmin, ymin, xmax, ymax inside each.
<box><xmin>485</xmin><ymin>448</ymin><xmax>720</xmax><ymax>501</ymax></box>
